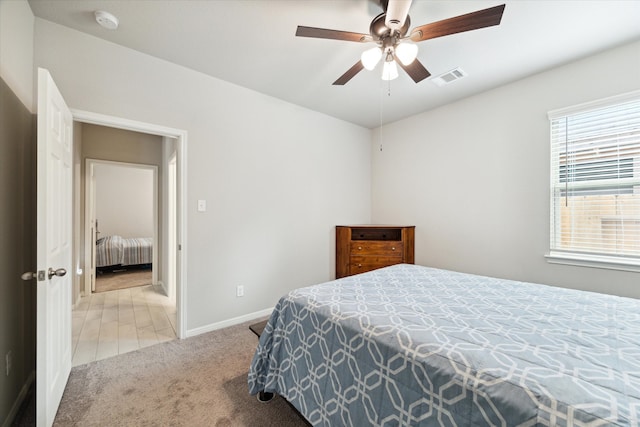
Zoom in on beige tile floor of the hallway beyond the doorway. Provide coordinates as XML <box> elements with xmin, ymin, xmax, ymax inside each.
<box><xmin>72</xmin><ymin>285</ymin><xmax>176</xmax><ymax>366</ymax></box>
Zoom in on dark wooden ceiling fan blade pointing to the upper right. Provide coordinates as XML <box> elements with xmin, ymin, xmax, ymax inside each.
<box><xmin>410</xmin><ymin>4</ymin><xmax>505</xmax><ymax>42</ymax></box>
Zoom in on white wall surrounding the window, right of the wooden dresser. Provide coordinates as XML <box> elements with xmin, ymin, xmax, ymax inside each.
<box><xmin>372</xmin><ymin>42</ymin><xmax>640</xmax><ymax>297</ymax></box>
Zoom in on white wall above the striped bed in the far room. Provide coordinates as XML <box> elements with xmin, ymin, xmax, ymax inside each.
<box><xmin>94</xmin><ymin>163</ymin><xmax>154</xmax><ymax>237</ymax></box>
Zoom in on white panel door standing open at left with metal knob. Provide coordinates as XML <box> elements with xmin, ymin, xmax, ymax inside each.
<box><xmin>36</xmin><ymin>68</ymin><xmax>73</xmax><ymax>427</ymax></box>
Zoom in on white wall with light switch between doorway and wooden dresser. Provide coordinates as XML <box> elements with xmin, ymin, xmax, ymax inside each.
<box><xmin>35</xmin><ymin>19</ymin><xmax>371</xmax><ymax>330</ymax></box>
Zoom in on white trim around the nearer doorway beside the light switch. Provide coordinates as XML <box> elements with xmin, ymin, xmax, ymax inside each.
<box><xmin>71</xmin><ymin>109</ymin><xmax>187</xmax><ymax>338</ymax></box>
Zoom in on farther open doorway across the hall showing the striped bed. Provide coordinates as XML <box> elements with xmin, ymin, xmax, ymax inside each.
<box><xmin>85</xmin><ymin>159</ymin><xmax>159</xmax><ymax>294</ymax></box>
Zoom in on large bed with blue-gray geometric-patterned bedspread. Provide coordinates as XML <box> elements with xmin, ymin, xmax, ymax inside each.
<box><xmin>248</xmin><ymin>264</ymin><xmax>640</xmax><ymax>426</ymax></box>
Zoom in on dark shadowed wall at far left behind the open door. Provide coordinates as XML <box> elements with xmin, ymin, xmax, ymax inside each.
<box><xmin>0</xmin><ymin>80</ymin><xmax>36</xmax><ymax>424</ymax></box>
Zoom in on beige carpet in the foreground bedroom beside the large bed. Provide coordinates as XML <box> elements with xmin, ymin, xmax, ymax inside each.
<box><xmin>54</xmin><ymin>320</ymin><xmax>309</xmax><ymax>427</ymax></box>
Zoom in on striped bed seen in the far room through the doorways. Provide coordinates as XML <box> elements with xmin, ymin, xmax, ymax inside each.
<box><xmin>96</xmin><ymin>235</ymin><xmax>153</xmax><ymax>268</ymax></box>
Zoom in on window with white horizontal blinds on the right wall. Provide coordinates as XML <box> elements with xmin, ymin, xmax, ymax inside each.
<box><xmin>548</xmin><ymin>91</ymin><xmax>640</xmax><ymax>270</ymax></box>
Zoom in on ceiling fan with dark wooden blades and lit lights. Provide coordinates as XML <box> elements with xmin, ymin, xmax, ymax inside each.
<box><xmin>296</xmin><ymin>0</ymin><xmax>505</xmax><ymax>85</ymax></box>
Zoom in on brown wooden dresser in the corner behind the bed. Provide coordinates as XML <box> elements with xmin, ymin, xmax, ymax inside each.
<box><xmin>336</xmin><ymin>225</ymin><xmax>415</xmax><ymax>279</ymax></box>
